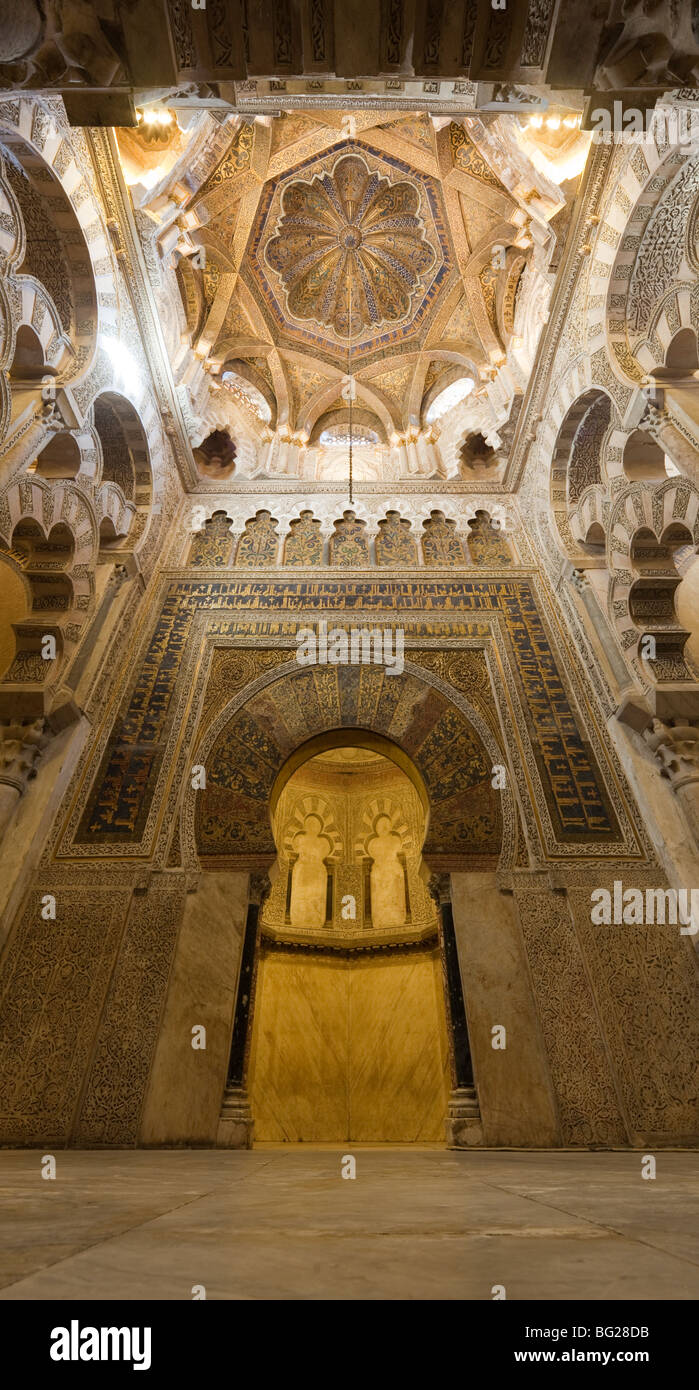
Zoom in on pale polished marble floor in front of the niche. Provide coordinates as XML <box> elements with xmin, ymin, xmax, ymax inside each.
<box><xmin>0</xmin><ymin>1145</ymin><xmax>699</xmax><ymax>1300</ymax></box>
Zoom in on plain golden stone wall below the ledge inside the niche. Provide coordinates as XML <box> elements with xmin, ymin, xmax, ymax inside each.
<box><xmin>250</xmin><ymin>947</ymin><xmax>449</xmax><ymax>1144</ymax></box>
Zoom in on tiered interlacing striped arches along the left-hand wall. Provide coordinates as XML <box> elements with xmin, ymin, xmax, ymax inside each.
<box><xmin>0</xmin><ymin>97</ymin><xmax>183</xmax><ymax>712</ymax></box>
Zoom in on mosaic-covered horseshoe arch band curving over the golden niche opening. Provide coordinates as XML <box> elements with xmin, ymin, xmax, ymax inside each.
<box><xmin>195</xmin><ymin>667</ymin><xmax>502</xmax><ymax>867</ymax></box>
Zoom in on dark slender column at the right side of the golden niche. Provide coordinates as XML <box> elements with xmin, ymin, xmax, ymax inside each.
<box><xmin>429</xmin><ymin>874</ymin><xmax>484</xmax><ymax>1148</ymax></box>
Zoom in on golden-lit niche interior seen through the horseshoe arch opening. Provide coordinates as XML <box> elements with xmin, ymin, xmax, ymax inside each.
<box><xmin>249</xmin><ymin>748</ymin><xmax>449</xmax><ymax>1144</ymax></box>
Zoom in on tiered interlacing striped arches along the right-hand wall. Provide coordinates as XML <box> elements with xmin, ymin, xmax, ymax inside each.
<box><xmin>529</xmin><ymin>123</ymin><xmax>699</xmax><ymax>700</ymax></box>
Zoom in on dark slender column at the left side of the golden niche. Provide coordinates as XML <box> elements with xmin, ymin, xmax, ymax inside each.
<box><xmin>217</xmin><ymin>873</ymin><xmax>271</xmax><ymax>1148</ymax></box>
